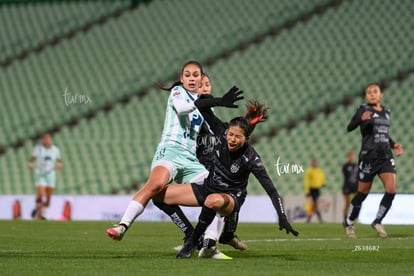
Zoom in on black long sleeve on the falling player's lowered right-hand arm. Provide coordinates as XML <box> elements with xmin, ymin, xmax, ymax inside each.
<box><xmin>251</xmin><ymin>156</ymin><xmax>286</xmax><ymax>218</ymax></box>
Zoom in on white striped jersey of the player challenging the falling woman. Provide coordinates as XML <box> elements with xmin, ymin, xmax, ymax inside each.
<box><xmin>158</xmin><ymin>86</ymin><xmax>204</xmax><ymax>154</ymax></box>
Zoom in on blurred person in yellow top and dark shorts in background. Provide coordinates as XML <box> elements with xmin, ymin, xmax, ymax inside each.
<box><xmin>304</xmin><ymin>158</ymin><xmax>326</xmax><ymax>223</ymax></box>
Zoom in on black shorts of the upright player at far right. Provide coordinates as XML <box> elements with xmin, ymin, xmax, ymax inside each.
<box><xmin>358</xmin><ymin>158</ymin><xmax>397</xmax><ymax>182</ymax></box>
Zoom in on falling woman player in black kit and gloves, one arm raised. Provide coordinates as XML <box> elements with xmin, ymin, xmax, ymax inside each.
<box><xmin>153</xmin><ymin>87</ymin><xmax>298</xmax><ymax>258</ymax></box>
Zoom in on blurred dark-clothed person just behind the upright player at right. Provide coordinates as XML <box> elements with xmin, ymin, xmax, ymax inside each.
<box><xmin>342</xmin><ymin>150</ymin><xmax>358</xmax><ymax>219</ymax></box>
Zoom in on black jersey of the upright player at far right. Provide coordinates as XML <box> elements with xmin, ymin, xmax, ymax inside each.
<box><xmin>347</xmin><ymin>104</ymin><xmax>395</xmax><ymax>160</ymax></box>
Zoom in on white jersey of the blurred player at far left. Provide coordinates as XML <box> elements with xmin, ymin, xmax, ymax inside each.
<box><xmin>32</xmin><ymin>144</ymin><xmax>61</xmax><ymax>174</ymax></box>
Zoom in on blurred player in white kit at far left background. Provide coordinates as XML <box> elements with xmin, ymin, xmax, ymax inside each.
<box><xmin>29</xmin><ymin>133</ymin><xmax>63</xmax><ymax>219</ymax></box>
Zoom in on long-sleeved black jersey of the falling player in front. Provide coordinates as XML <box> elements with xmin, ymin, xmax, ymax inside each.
<box><xmin>200</xmin><ymin>106</ymin><xmax>284</xmax><ymax>216</ymax></box>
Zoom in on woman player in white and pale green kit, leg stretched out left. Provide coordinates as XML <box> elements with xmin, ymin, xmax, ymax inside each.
<box><xmin>106</xmin><ymin>61</ymin><xmax>223</xmax><ymax>249</ymax></box>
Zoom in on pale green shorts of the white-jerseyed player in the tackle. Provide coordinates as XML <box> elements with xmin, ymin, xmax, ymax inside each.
<box><xmin>151</xmin><ymin>146</ymin><xmax>208</xmax><ymax>183</ymax></box>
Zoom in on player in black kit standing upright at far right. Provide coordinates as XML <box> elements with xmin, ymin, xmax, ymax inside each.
<box><xmin>344</xmin><ymin>84</ymin><xmax>403</xmax><ymax>238</ymax></box>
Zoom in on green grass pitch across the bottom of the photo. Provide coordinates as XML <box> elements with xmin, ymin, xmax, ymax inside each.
<box><xmin>0</xmin><ymin>221</ymin><xmax>414</xmax><ymax>275</ymax></box>
